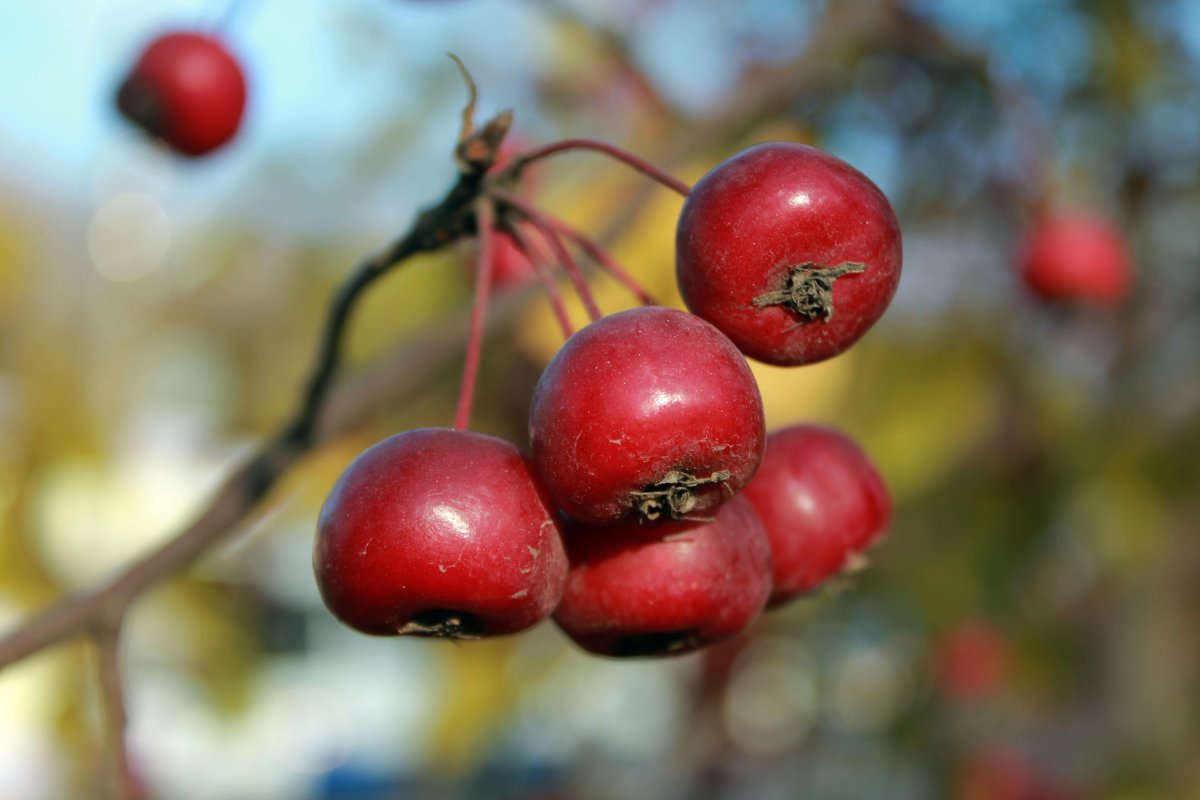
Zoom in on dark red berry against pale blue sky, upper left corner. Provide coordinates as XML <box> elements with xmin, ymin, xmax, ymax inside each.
<box><xmin>116</xmin><ymin>32</ymin><xmax>246</xmax><ymax>156</ymax></box>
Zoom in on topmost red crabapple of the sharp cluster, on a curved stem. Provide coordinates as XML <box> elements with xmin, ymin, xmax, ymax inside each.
<box><xmin>676</xmin><ymin>142</ymin><xmax>901</xmax><ymax>366</ymax></box>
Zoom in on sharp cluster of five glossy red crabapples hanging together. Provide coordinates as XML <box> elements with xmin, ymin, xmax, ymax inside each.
<box><xmin>313</xmin><ymin>143</ymin><xmax>900</xmax><ymax>656</ymax></box>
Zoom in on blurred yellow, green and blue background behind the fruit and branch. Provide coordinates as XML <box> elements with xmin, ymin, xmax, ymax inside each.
<box><xmin>0</xmin><ymin>0</ymin><xmax>1200</xmax><ymax>800</ymax></box>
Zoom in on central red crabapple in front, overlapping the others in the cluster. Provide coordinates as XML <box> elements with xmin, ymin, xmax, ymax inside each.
<box><xmin>529</xmin><ymin>307</ymin><xmax>766</xmax><ymax>524</ymax></box>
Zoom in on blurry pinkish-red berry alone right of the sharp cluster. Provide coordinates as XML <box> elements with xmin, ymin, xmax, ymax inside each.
<box><xmin>1018</xmin><ymin>213</ymin><xmax>1133</xmax><ymax>305</ymax></box>
